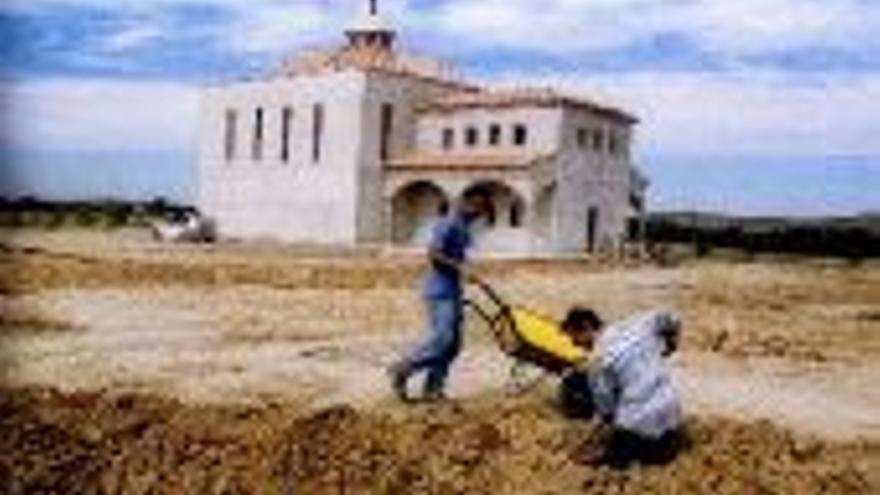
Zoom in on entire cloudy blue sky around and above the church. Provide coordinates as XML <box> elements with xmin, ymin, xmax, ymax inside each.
<box><xmin>0</xmin><ymin>0</ymin><xmax>880</xmax><ymax>215</ymax></box>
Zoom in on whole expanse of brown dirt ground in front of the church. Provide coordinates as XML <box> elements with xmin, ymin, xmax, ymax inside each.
<box><xmin>0</xmin><ymin>231</ymin><xmax>880</xmax><ymax>494</ymax></box>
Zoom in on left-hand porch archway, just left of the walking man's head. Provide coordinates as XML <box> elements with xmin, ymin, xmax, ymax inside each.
<box><xmin>391</xmin><ymin>180</ymin><xmax>449</xmax><ymax>244</ymax></box>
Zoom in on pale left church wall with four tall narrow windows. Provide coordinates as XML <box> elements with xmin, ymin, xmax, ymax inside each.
<box><xmin>198</xmin><ymin>72</ymin><xmax>365</xmax><ymax>244</ymax></box>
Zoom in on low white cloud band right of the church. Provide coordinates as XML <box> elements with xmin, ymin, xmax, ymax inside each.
<box><xmin>484</xmin><ymin>73</ymin><xmax>880</xmax><ymax>156</ymax></box>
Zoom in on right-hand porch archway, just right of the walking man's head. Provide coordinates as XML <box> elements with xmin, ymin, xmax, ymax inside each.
<box><xmin>461</xmin><ymin>180</ymin><xmax>530</xmax><ymax>253</ymax></box>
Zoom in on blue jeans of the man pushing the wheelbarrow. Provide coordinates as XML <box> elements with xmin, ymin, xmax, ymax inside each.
<box><xmin>397</xmin><ymin>298</ymin><xmax>462</xmax><ymax>394</ymax></box>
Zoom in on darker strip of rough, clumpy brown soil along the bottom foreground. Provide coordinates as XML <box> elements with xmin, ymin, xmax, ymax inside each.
<box><xmin>0</xmin><ymin>390</ymin><xmax>880</xmax><ymax>494</ymax></box>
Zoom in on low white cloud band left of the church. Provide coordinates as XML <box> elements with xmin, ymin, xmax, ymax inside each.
<box><xmin>0</xmin><ymin>79</ymin><xmax>198</xmax><ymax>150</ymax></box>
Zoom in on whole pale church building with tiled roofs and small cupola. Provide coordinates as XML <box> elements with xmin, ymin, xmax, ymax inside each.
<box><xmin>197</xmin><ymin>2</ymin><xmax>647</xmax><ymax>255</ymax></box>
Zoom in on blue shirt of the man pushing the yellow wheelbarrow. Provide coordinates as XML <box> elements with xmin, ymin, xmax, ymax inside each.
<box><xmin>423</xmin><ymin>214</ymin><xmax>471</xmax><ymax>299</ymax></box>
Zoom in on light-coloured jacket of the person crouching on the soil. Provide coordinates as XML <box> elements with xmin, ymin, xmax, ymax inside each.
<box><xmin>590</xmin><ymin>311</ymin><xmax>682</xmax><ymax>438</ymax></box>
